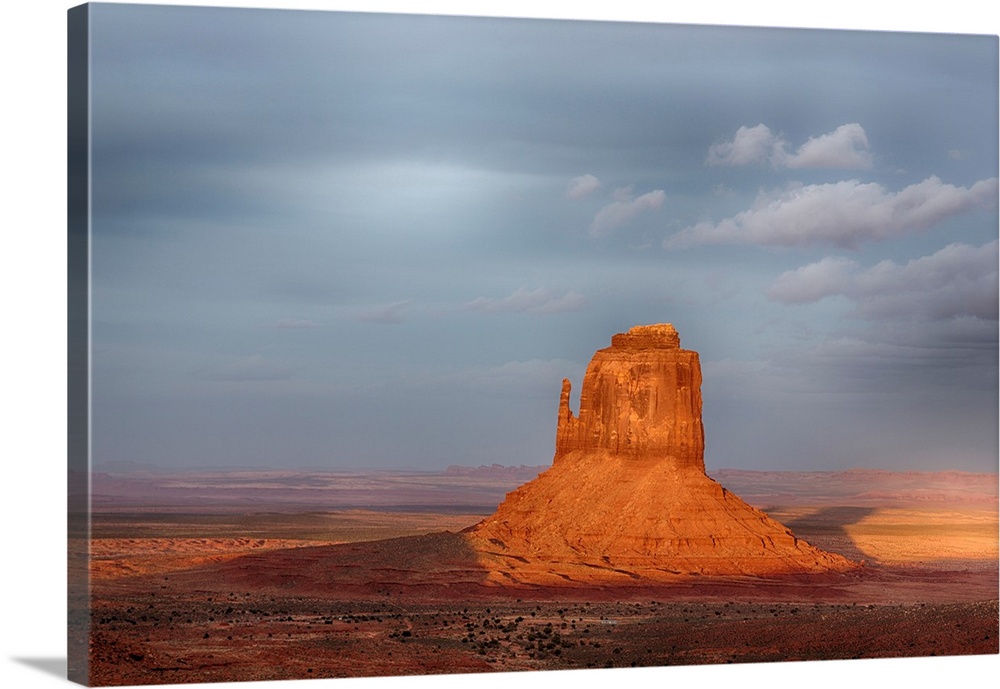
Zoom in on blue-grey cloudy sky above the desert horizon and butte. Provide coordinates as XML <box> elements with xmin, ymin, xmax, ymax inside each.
<box><xmin>91</xmin><ymin>4</ymin><xmax>998</xmax><ymax>471</ymax></box>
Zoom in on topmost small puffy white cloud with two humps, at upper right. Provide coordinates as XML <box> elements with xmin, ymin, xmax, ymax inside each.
<box><xmin>706</xmin><ymin>122</ymin><xmax>872</xmax><ymax>170</ymax></box>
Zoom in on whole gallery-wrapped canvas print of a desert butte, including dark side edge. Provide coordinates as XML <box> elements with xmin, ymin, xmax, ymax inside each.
<box><xmin>68</xmin><ymin>3</ymin><xmax>998</xmax><ymax>686</ymax></box>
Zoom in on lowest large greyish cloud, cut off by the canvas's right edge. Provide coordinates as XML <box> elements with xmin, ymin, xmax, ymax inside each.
<box><xmin>768</xmin><ymin>241</ymin><xmax>1000</xmax><ymax>321</ymax></box>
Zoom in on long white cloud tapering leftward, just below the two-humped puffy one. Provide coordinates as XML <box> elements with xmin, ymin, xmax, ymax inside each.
<box><xmin>663</xmin><ymin>177</ymin><xmax>997</xmax><ymax>249</ymax></box>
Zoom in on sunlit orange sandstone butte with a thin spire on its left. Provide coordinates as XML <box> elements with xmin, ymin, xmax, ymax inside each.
<box><xmin>463</xmin><ymin>323</ymin><xmax>858</xmax><ymax>586</ymax></box>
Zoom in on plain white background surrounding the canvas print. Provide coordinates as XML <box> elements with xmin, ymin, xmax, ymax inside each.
<box><xmin>0</xmin><ymin>0</ymin><xmax>1000</xmax><ymax>689</ymax></box>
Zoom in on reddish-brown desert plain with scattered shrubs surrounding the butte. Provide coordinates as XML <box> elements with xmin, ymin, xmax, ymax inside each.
<box><xmin>82</xmin><ymin>467</ymin><xmax>998</xmax><ymax>685</ymax></box>
